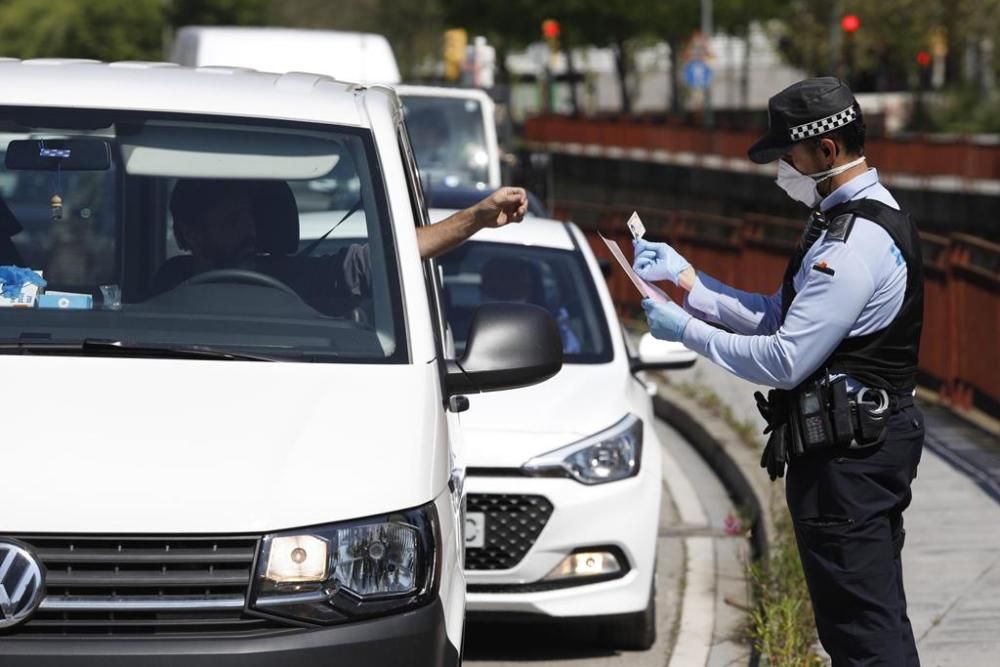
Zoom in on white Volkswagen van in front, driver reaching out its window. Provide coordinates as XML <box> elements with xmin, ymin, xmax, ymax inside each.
<box><xmin>0</xmin><ymin>59</ymin><xmax>561</xmax><ymax>667</ymax></box>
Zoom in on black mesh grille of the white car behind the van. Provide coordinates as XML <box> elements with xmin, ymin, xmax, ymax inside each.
<box><xmin>465</xmin><ymin>494</ymin><xmax>552</xmax><ymax>570</ymax></box>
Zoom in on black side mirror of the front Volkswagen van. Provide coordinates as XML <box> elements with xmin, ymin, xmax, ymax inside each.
<box><xmin>446</xmin><ymin>303</ymin><xmax>562</xmax><ymax>396</ymax></box>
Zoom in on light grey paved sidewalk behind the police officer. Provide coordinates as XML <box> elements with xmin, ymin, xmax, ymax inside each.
<box><xmin>669</xmin><ymin>360</ymin><xmax>1000</xmax><ymax>667</ymax></box>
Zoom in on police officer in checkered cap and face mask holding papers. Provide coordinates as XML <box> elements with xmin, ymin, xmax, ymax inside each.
<box><xmin>635</xmin><ymin>77</ymin><xmax>924</xmax><ymax>666</ymax></box>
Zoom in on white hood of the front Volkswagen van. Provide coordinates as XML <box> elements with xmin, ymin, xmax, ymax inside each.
<box><xmin>0</xmin><ymin>356</ymin><xmax>450</xmax><ymax>534</ymax></box>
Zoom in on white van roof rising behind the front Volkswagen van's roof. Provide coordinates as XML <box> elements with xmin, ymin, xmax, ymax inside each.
<box><xmin>170</xmin><ymin>26</ymin><xmax>400</xmax><ymax>84</ymax></box>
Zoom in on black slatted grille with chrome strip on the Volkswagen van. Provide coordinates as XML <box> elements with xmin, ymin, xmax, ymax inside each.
<box><xmin>5</xmin><ymin>536</ymin><xmax>288</xmax><ymax>635</ymax></box>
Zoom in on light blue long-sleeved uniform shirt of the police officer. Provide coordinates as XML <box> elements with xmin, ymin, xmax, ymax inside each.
<box><xmin>683</xmin><ymin>169</ymin><xmax>906</xmax><ymax>389</ymax></box>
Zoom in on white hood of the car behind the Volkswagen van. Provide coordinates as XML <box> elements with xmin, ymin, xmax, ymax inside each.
<box><xmin>462</xmin><ymin>363</ymin><xmax>636</xmax><ymax>468</ymax></box>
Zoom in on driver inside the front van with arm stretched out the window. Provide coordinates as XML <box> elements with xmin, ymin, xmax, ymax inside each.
<box><xmin>152</xmin><ymin>179</ymin><xmax>528</xmax><ymax>310</ymax></box>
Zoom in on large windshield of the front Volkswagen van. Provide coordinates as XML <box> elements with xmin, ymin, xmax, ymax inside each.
<box><xmin>0</xmin><ymin>108</ymin><xmax>407</xmax><ymax>363</ymax></box>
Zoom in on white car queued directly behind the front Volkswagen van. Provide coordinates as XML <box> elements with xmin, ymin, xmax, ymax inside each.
<box><xmin>431</xmin><ymin>206</ymin><xmax>696</xmax><ymax>649</ymax></box>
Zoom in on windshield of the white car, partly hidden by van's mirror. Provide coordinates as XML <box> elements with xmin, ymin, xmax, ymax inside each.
<box><xmin>439</xmin><ymin>240</ymin><xmax>612</xmax><ymax>364</ymax></box>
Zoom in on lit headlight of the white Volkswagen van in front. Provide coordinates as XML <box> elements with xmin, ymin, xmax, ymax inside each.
<box><xmin>251</xmin><ymin>504</ymin><xmax>438</xmax><ymax>624</ymax></box>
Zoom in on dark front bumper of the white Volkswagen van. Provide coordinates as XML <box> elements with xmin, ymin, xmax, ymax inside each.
<box><xmin>0</xmin><ymin>599</ymin><xmax>459</xmax><ymax>667</ymax></box>
